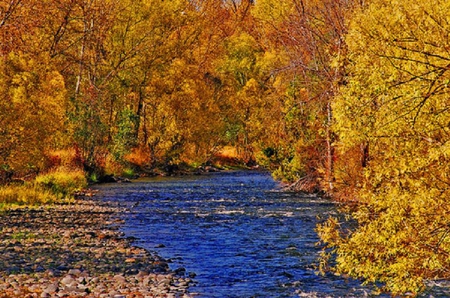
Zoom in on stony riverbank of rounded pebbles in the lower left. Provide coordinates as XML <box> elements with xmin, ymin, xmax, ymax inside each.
<box><xmin>0</xmin><ymin>198</ymin><xmax>192</xmax><ymax>298</ymax></box>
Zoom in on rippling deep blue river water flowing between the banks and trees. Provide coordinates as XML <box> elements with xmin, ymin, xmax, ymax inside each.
<box><xmin>93</xmin><ymin>171</ymin><xmax>444</xmax><ymax>298</ymax></box>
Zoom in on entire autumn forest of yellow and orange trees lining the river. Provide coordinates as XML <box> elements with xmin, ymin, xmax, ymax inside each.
<box><xmin>0</xmin><ymin>0</ymin><xmax>450</xmax><ymax>294</ymax></box>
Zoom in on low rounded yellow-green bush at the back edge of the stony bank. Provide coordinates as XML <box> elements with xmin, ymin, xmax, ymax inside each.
<box><xmin>36</xmin><ymin>167</ymin><xmax>87</xmax><ymax>197</ymax></box>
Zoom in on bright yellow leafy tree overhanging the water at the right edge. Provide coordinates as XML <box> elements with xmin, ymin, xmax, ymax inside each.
<box><xmin>319</xmin><ymin>0</ymin><xmax>450</xmax><ymax>294</ymax></box>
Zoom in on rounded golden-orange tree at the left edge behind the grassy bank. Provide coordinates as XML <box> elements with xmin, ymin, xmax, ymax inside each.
<box><xmin>0</xmin><ymin>52</ymin><xmax>67</xmax><ymax>182</ymax></box>
